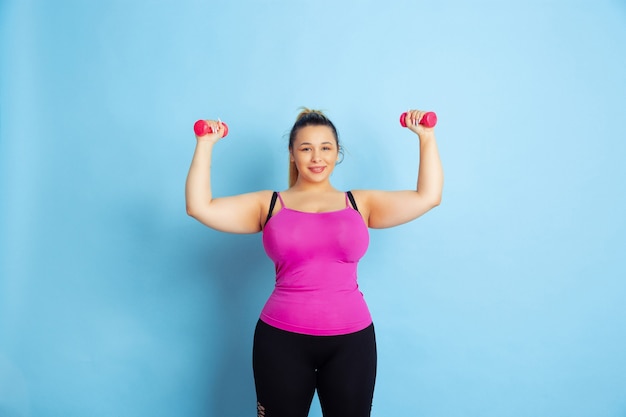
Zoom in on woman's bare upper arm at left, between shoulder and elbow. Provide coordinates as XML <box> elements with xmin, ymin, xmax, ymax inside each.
<box><xmin>188</xmin><ymin>191</ymin><xmax>272</xmax><ymax>233</ymax></box>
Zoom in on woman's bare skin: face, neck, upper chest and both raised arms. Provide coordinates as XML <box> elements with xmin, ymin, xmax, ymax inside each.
<box><xmin>185</xmin><ymin>110</ymin><xmax>443</xmax><ymax>233</ymax></box>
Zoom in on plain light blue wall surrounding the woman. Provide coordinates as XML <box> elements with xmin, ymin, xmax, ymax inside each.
<box><xmin>0</xmin><ymin>0</ymin><xmax>626</xmax><ymax>417</ymax></box>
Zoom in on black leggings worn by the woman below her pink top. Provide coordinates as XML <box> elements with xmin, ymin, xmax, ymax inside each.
<box><xmin>252</xmin><ymin>320</ymin><xmax>376</xmax><ymax>417</ymax></box>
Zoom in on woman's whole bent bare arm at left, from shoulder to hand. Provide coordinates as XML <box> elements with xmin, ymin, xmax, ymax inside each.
<box><xmin>185</xmin><ymin>121</ymin><xmax>271</xmax><ymax>233</ymax></box>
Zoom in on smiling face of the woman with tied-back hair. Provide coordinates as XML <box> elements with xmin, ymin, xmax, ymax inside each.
<box><xmin>291</xmin><ymin>126</ymin><xmax>339</xmax><ymax>182</ymax></box>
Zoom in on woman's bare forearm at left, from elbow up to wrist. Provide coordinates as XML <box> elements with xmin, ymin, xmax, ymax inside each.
<box><xmin>185</xmin><ymin>141</ymin><xmax>214</xmax><ymax>216</ymax></box>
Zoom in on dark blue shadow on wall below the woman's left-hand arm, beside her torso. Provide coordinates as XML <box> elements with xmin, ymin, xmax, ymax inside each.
<box><xmin>182</xmin><ymin>226</ymin><xmax>266</xmax><ymax>416</ymax></box>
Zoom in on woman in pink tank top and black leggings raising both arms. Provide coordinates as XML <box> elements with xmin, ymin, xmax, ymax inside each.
<box><xmin>186</xmin><ymin>109</ymin><xmax>443</xmax><ymax>417</ymax></box>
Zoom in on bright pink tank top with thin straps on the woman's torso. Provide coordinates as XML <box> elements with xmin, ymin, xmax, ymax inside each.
<box><xmin>261</xmin><ymin>194</ymin><xmax>372</xmax><ymax>336</ymax></box>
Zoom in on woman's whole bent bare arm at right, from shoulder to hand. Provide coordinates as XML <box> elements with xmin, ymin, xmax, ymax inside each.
<box><xmin>354</xmin><ymin>110</ymin><xmax>443</xmax><ymax>229</ymax></box>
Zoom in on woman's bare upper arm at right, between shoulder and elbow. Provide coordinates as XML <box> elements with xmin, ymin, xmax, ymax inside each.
<box><xmin>353</xmin><ymin>190</ymin><xmax>439</xmax><ymax>229</ymax></box>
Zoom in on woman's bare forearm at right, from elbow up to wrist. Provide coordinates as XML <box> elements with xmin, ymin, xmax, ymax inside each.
<box><xmin>417</xmin><ymin>132</ymin><xmax>443</xmax><ymax>205</ymax></box>
